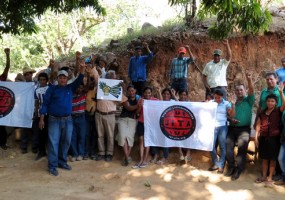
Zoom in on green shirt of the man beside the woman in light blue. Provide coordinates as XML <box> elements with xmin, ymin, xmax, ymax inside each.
<box><xmin>230</xmin><ymin>94</ymin><xmax>255</xmax><ymax>127</ymax></box>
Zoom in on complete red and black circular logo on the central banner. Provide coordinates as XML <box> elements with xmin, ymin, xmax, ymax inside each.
<box><xmin>160</xmin><ymin>105</ymin><xmax>196</xmax><ymax>140</ymax></box>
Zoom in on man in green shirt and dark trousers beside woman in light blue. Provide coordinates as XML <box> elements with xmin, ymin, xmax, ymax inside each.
<box><xmin>225</xmin><ymin>73</ymin><xmax>255</xmax><ymax>180</ymax></box>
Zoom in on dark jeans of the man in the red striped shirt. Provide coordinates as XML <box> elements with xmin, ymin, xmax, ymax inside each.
<box><xmin>70</xmin><ymin>113</ymin><xmax>86</xmax><ymax>158</ymax></box>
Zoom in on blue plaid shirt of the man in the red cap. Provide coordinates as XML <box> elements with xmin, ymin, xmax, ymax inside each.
<box><xmin>170</xmin><ymin>57</ymin><xmax>193</xmax><ymax>79</ymax></box>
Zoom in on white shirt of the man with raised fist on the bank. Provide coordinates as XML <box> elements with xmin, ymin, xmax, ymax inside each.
<box><xmin>203</xmin><ymin>59</ymin><xmax>230</xmax><ymax>88</ymax></box>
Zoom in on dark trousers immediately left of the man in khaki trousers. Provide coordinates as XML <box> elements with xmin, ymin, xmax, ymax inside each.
<box><xmin>84</xmin><ymin>113</ymin><xmax>98</xmax><ymax>156</ymax></box>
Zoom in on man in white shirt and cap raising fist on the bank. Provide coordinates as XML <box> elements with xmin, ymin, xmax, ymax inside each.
<box><xmin>202</xmin><ymin>40</ymin><xmax>232</xmax><ymax>98</ymax></box>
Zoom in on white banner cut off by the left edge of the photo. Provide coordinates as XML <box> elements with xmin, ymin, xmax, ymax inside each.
<box><xmin>0</xmin><ymin>82</ymin><xmax>35</xmax><ymax>128</ymax></box>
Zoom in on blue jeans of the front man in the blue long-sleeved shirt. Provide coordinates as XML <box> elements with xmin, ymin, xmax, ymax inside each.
<box><xmin>48</xmin><ymin>115</ymin><xmax>73</xmax><ymax>170</ymax></box>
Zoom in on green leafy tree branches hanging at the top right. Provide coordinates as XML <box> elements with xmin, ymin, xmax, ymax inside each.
<box><xmin>169</xmin><ymin>0</ymin><xmax>272</xmax><ymax>39</ymax></box>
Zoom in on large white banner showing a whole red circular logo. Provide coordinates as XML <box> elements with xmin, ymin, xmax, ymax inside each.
<box><xmin>143</xmin><ymin>100</ymin><xmax>217</xmax><ymax>151</ymax></box>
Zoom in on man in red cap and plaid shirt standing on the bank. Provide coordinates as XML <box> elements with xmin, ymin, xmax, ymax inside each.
<box><xmin>170</xmin><ymin>45</ymin><xmax>194</xmax><ymax>93</ymax></box>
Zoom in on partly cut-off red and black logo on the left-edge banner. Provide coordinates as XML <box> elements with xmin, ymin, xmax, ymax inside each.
<box><xmin>0</xmin><ymin>86</ymin><xmax>15</xmax><ymax>118</ymax></box>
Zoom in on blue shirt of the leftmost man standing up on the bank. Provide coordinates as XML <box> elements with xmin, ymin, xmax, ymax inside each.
<box><xmin>128</xmin><ymin>53</ymin><xmax>153</xmax><ymax>82</ymax></box>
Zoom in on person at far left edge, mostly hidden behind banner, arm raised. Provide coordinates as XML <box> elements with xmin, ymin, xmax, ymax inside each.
<box><xmin>0</xmin><ymin>48</ymin><xmax>10</xmax><ymax>150</ymax></box>
